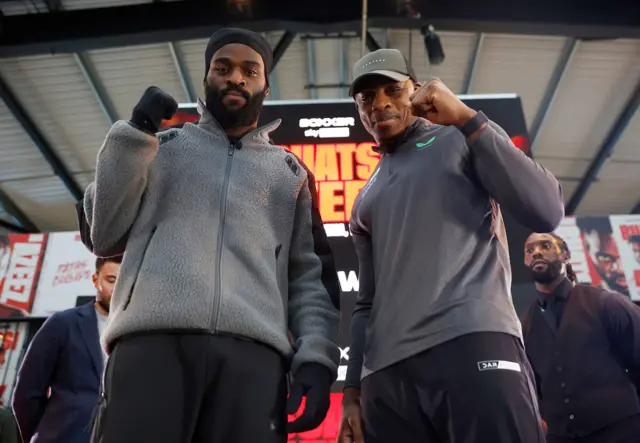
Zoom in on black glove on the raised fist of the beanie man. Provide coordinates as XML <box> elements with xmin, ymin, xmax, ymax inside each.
<box><xmin>131</xmin><ymin>86</ymin><xmax>178</xmax><ymax>134</ymax></box>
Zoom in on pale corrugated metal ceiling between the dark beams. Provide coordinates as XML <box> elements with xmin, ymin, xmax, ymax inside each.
<box><xmin>0</xmin><ymin>10</ymin><xmax>640</xmax><ymax>231</ymax></box>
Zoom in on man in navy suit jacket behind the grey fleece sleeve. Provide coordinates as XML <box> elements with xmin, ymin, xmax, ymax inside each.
<box><xmin>13</xmin><ymin>257</ymin><xmax>121</xmax><ymax>443</ymax></box>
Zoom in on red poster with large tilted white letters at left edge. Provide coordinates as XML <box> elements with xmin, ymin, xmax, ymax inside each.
<box><xmin>0</xmin><ymin>234</ymin><xmax>47</xmax><ymax>319</ymax></box>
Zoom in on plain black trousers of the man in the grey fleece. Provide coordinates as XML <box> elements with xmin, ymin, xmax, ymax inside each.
<box><xmin>92</xmin><ymin>333</ymin><xmax>287</xmax><ymax>443</ymax></box>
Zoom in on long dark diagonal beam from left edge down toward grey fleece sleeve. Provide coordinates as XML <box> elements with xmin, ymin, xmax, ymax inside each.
<box><xmin>0</xmin><ymin>75</ymin><xmax>84</xmax><ymax>200</ymax></box>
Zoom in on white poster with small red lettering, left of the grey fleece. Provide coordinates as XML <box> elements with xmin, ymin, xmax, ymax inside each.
<box><xmin>31</xmin><ymin>232</ymin><xmax>96</xmax><ymax>317</ymax></box>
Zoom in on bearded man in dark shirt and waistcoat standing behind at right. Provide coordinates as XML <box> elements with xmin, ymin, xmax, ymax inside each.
<box><xmin>523</xmin><ymin>234</ymin><xmax>640</xmax><ymax>443</ymax></box>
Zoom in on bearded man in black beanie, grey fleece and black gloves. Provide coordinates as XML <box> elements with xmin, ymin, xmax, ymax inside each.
<box><xmin>87</xmin><ymin>29</ymin><xmax>339</xmax><ymax>443</ymax></box>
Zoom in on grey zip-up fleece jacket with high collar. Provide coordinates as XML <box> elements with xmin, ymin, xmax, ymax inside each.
<box><xmin>84</xmin><ymin>106</ymin><xmax>339</xmax><ymax>378</ymax></box>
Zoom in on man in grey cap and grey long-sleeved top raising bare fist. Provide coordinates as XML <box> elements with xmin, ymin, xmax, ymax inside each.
<box><xmin>339</xmin><ymin>49</ymin><xmax>564</xmax><ymax>443</ymax></box>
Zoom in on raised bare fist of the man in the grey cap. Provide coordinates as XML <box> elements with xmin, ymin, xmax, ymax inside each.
<box><xmin>409</xmin><ymin>78</ymin><xmax>476</xmax><ymax>127</ymax></box>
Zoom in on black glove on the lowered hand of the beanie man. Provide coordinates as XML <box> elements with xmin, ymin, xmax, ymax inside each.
<box><xmin>287</xmin><ymin>363</ymin><xmax>331</xmax><ymax>434</ymax></box>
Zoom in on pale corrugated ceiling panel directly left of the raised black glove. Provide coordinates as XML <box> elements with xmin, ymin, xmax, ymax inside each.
<box><xmin>0</xmin><ymin>54</ymin><xmax>109</xmax><ymax>172</ymax></box>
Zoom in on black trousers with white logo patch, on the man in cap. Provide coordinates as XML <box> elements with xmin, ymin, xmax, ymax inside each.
<box><xmin>361</xmin><ymin>332</ymin><xmax>545</xmax><ymax>443</ymax></box>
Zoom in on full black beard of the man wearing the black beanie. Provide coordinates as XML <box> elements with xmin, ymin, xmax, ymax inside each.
<box><xmin>204</xmin><ymin>82</ymin><xmax>267</xmax><ymax>130</ymax></box>
